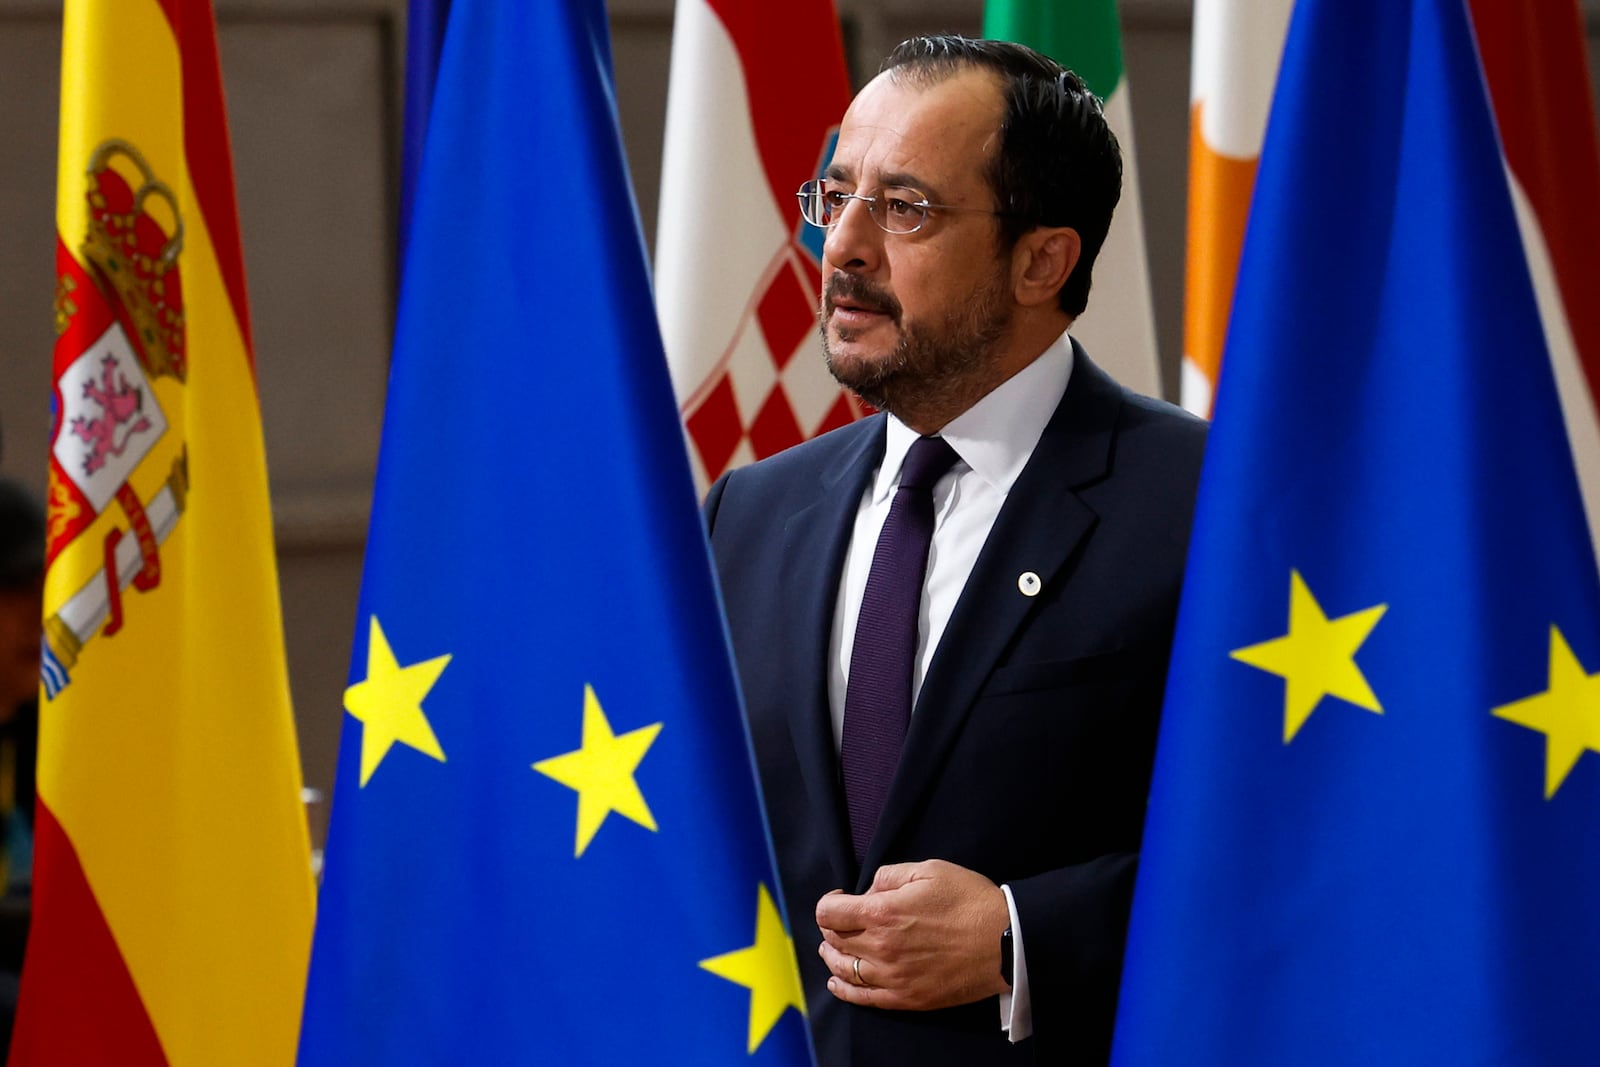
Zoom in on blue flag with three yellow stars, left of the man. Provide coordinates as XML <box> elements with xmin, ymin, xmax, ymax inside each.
<box><xmin>301</xmin><ymin>0</ymin><xmax>810</xmax><ymax>1065</ymax></box>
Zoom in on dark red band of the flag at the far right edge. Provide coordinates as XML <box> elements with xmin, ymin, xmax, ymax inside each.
<box><xmin>1470</xmin><ymin>0</ymin><xmax>1600</xmax><ymax>405</ymax></box>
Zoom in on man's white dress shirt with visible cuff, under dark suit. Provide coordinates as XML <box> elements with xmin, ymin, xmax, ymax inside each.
<box><xmin>827</xmin><ymin>334</ymin><xmax>1072</xmax><ymax>1041</ymax></box>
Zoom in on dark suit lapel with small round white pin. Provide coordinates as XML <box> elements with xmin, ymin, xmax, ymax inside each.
<box><xmin>858</xmin><ymin>355</ymin><xmax>1122</xmax><ymax>891</ymax></box>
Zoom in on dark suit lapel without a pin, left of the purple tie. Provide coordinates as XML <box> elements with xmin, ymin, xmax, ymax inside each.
<box><xmin>773</xmin><ymin>416</ymin><xmax>885</xmax><ymax>886</ymax></box>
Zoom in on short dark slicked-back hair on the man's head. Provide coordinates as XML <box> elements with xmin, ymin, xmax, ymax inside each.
<box><xmin>883</xmin><ymin>34</ymin><xmax>1122</xmax><ymax>315</ymax></box>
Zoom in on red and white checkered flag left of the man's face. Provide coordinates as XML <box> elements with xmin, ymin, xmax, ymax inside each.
<box><xmin>656</xmin><ymin>0</ymin><xmax>862</xmax><ymax>491</ymax></box>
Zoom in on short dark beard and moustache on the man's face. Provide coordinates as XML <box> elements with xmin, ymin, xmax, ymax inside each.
<box><xmin>821</xmin><ymin>270</ymin><xmax>1011</xmax><ymax>421</ymax></box>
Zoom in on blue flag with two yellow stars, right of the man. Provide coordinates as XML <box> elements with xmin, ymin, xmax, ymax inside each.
<box><xmin>1114</xmin><ymin>0</ymin><xmax>1600</xmax><ymax>1067</ymax></box>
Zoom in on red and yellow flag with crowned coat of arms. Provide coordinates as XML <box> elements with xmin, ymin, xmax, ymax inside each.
<box><xmin>11</xmin><ymin>0</ymin><xmax>312</xmax><ymax>1067</ymax></box>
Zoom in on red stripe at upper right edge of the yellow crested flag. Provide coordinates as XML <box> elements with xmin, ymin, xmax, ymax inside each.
<box><xmin>160</xmin><ymin>0</ymin><xmax>256</xmax><ymax>379</ymax></box>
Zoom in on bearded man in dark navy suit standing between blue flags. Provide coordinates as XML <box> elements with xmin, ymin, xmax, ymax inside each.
<box><xmin>706</xmin><ymin>37</ymin><xmax>1205</xmax><ymax>1065</ymax></box>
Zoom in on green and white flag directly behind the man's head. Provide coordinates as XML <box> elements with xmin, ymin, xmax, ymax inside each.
<box><xmin>984</xmin><ymin>0</ymin><xmax>1162</xmax><ymax>397</ymax></box>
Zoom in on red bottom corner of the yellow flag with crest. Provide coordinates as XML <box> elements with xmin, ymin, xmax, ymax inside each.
<box><xmin>8</xmin><ymin>798</ymin><xmax>166</xmax><ymax>1067</ymax></box>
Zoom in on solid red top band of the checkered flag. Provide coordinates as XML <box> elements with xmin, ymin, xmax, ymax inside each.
<box><xmin>706</xmin><ymin>0</ymin><xmax>850</xmax><ymax>218</ymax></box>
